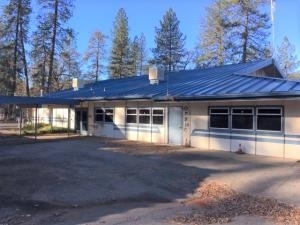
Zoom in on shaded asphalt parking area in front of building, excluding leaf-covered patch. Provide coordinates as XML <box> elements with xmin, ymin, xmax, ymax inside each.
<box><xmin>0</xmin><ymin>137</ymin><xmax>300</xmax><ymax>225</ymax></box>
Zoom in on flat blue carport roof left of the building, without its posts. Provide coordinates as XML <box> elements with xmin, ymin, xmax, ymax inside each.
<box><xmin>0</xmin><ymin>96</ymin><xmax>79</xmax><ymax>106</ymax></box>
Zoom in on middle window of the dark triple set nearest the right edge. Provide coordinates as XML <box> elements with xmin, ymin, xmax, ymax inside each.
<box><xmin>231</xmin><ymin>108</ymin><xmax>254</xmax><ymax>130</ymax></box>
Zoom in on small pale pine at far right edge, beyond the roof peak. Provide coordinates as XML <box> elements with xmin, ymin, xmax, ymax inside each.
<box><xmin>276</xmin><ymin>36</ymin><xmax>300</xmax><ymax>77</ymax></box>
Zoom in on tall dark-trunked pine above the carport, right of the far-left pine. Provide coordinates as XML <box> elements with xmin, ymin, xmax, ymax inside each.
<box><xmin>33</xmin><ymin>0</ymin><xmax>73</xmax><ymax>92</ymax></box>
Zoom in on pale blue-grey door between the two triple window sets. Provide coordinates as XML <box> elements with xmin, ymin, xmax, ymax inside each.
<box><xmin>168</xmin><ymin>107</ymin><xmax>183</xmax><ymax>145</ymax></box>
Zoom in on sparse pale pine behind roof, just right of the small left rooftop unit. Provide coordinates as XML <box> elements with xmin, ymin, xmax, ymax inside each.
<box><xmin>84</xmin><ymin>31</ymin><xmax>107</xmax><ymax>81</ymax></box>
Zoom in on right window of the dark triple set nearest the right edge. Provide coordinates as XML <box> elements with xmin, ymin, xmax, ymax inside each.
<box><xmin>257</xmin><ymin>107</ymin><xmax>282</xmax><ymax>131</ymax></box>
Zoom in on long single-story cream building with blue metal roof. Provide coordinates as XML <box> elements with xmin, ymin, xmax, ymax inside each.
<box><xmin>4</xmin><ymin>59</ymin><xmax>300</xmax><ymax>159</ymax></box>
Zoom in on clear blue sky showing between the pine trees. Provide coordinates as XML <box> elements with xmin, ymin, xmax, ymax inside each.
<box><xmin>0</xmin><ymin>0</ymin><xmax>300</xmax><ymax>70</ymax></box>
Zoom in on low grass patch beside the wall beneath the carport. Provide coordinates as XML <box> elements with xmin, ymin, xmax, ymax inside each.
<box><xmin>22</xmin><ymin>123</ymin><xmax>75</xmax><ymax>135</ymax></box>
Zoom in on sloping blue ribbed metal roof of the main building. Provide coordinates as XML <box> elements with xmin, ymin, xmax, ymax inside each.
<box><xmin>50</xmin><ymin>60</ymin><xmax>300</xmax><ymax>100</ymax></box>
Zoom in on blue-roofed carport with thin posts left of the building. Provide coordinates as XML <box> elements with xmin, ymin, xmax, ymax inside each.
<box><xmin>0</xmin><ymin>96</ymin><xmax>80</xmax><ymax>140</ymax></box>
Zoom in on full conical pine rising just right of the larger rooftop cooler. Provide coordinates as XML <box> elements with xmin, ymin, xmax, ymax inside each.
<box><xmin>152</xmin><ymin>9</ymin><xmax>186</xmax><ymax>71</ymax></box>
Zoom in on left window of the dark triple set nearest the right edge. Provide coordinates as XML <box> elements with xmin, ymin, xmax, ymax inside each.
<box><xmin>209</xmin><ymin>108</ymin><xmax>229</xmax><ymax>128</ymax></box>
